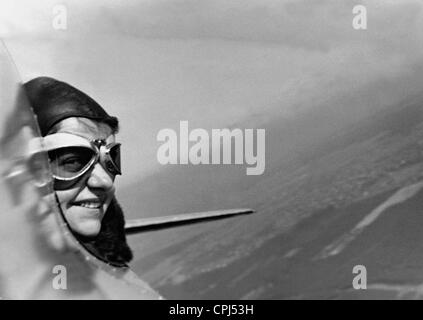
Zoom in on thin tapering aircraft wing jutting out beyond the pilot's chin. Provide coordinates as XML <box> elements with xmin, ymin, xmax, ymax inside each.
<box><xmin>125</xmin><ymin>208</ymin><xmax>255</xmax><ymax>235</ymax></box>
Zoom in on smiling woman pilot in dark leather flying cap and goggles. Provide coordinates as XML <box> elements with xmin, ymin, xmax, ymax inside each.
<box><xmin>24</xmin><ymin>77</ymin><xmax>132</xmax><ymax>266</ymax></box>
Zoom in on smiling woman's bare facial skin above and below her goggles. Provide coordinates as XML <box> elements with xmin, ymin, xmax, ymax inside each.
<box><xmin>50</xmin><ymin>117</ymin><xmax>115</xmax><ymax>237</ymax></box>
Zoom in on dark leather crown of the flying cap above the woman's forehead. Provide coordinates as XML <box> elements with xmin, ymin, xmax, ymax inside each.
<box><xmin>24</xmin><ymin>77</ymin><xmax>117</xmax><ymax>136</ymax></box>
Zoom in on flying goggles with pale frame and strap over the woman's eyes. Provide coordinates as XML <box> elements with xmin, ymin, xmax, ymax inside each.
<box><xmin>37</xmin><ymin>133</ymin><xmax>121</xmax><ymax>181</ymax></box>
